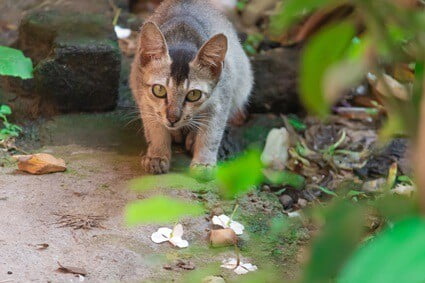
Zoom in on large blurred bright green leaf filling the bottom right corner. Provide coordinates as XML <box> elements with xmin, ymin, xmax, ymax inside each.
<box><xmin>338</xmin><ymin>217</ymin><xmax>425</xmax><ymax>283</ymax></box>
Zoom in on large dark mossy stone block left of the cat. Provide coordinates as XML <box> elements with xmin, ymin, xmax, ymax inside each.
<box><xmin>8</xmin><ymin>11</ymin><xmax>121</xmax><ymax>112</ymax></box>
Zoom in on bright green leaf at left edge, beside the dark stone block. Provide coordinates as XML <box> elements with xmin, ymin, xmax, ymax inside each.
<box><xmin>0</xmin><ymin>46</ymin><xmax>33</xmax><ymax>79</ymax></box>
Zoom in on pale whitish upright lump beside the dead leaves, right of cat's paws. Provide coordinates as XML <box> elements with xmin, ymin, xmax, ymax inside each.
<box><xmin>261</xmin><ymin>128</ymin><xmax>290</xmax><ymax>170</ymax></box>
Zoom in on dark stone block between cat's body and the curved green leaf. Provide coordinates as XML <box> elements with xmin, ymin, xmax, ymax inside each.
<box><xmin>249</xmin><ymin>48</ymin><xmax>302</xmax><ymax>113</ymax></box>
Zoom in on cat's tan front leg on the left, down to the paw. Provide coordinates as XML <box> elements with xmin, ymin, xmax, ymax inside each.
<box><xmin>142</xmin><ymin>117</ymin><xmax>171</xmax><ymax>174</ymax></box>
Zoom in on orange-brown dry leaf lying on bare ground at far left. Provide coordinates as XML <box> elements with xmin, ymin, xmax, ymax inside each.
<box><xmin>14</xmin><ymin>153</ymin><xmax>66</xmax><ymax>175</ymax></box>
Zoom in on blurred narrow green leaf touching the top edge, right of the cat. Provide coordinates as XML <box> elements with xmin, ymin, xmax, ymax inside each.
<box><xmin>270</xmin><ymin>0</ymin><xmax>334</xmax><ymax>35</ymax></box>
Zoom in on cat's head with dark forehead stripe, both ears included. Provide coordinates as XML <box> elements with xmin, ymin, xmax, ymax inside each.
<box><xmin>135</xmin><ymin>22</ymin><xmax>227</xmax><ymax>129</ymax></box>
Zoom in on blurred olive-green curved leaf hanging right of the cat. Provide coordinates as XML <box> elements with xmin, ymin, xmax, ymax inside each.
<box><xmin>300</xmin><ymin>22</ymin><xmax>355</xmax><ymax>117</ymax></box>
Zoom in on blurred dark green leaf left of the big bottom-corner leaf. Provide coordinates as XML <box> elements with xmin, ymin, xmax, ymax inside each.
<box><xmin>303</xmin><ymin>201</ymin><xmax>363</xmax><ymax>283</ymax></box>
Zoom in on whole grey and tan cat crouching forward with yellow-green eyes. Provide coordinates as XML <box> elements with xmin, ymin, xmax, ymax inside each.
<box><xmin>130</xmin><ymin>0</ymin><xmax>253</xmax><ymax>174</ymax></box>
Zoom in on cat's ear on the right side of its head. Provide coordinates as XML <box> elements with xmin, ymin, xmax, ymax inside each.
<box><xmin>195</xmin><ymin>34</ymin><xmax>227</xmax><ymax>77</ymax></box>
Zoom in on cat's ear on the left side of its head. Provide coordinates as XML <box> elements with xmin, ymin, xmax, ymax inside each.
<box><xmin>138</xmin><ymin>22</ymin><xmax>168</xmax><ymax>65</ymax></box>
